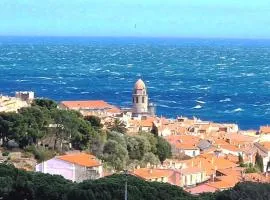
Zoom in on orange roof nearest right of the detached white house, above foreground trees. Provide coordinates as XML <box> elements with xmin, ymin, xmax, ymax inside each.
<box><xmin>132</xmin><ymin>168</ymin><xmax>174</xmax><ymax>180</ymax></box>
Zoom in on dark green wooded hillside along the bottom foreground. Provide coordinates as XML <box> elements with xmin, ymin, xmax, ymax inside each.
<box><xmin>0</xmin><ymin>164</ymin><xmax>270</xmax><ymax>200</ymax></box>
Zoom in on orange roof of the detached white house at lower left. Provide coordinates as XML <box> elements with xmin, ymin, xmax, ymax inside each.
<box><xmin>56</xmin><ymin>153</ymin><xmax>101</xmax><ymax>167</ymax></box>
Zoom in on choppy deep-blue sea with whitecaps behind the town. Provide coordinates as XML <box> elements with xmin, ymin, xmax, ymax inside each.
<box><xmin>0</xmin><ymin>37</ymin><xmax>270</xmax><ymax>129</ymax></box>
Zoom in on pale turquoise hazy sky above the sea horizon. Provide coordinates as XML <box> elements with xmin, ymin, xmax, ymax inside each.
<box><xmin>0</xmin><ymin>0</ymin><xmax>270</xmax><ymax>38</ymax></box>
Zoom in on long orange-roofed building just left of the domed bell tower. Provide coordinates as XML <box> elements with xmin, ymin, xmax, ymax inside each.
<box><xmin>59</xmin><ymin>100</ymin><xmax>121</xmax><ymax>116</ymax></box>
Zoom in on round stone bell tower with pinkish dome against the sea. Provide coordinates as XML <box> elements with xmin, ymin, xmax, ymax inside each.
<box><xmin>132</xmin><ymin>79</ymin><xmax>148</xmax><ymax>114</ymax></box>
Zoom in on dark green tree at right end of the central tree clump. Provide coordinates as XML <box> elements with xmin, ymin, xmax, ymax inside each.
<box><xmin>157</xmin><ymin>137</ymin><xmax>172</xmax><ymax>163</ymax></box>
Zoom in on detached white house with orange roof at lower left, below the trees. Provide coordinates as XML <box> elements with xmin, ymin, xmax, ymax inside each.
<box><xmin>36</xmin><ymin>153</ymin><xmax>103</xmax><ymax>182</ymax></box>
